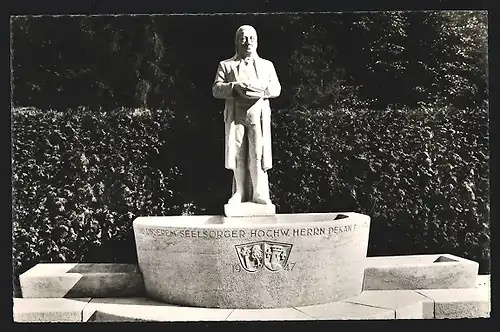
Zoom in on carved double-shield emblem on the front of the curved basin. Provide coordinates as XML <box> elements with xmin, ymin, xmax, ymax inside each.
<box><xmin>235</xmin><ymin>241</ymin><xmax>292</xmax><ymax>272</ymax></box>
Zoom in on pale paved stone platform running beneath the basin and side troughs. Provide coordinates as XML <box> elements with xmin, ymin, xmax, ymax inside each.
<box><xmin>14</xmin><ymin>286</ymin><xmax>491</xmax><ymax>322</ymax></box>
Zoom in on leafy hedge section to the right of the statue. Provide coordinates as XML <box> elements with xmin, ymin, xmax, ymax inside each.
<box><xmin>270</xmin><ymin>107</ymin><xmax>490</xmax><ymax>270</ymax></box>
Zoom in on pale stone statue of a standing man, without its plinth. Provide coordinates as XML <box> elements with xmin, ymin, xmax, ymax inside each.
<box><xmin>212</xmin><ymin>25</ymin><xmax>281</xmax><ymax>204</ymax></box>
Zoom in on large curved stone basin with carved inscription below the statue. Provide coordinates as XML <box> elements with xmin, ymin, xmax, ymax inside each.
<box><xmin>134</xmin><ymin>213</ymin><xmax>370</xmax><ymax>309</ymax></box>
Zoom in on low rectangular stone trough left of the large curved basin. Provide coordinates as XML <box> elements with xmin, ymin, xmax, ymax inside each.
<box><xmin>19</xmin><ymin>263</ymin><xmax>145</xmax><ymax>298</ymax></box>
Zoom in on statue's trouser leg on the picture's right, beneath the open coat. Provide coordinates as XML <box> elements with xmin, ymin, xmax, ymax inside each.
<box><xmin>248</xmin><ymin>122</ymin><xmax>269</xmax><ymax>203</ymax></box>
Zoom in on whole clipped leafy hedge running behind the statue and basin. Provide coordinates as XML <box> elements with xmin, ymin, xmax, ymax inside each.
<box><xmin>12</xmin><ymin>107</ymin><xmax>490</xmax><ymax>286</ymax></box>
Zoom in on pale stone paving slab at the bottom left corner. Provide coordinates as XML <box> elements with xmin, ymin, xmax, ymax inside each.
<box><xmin>13</xmin><ymin>298</ymin><xmax>90</xmax><ymax>323</ymax></box>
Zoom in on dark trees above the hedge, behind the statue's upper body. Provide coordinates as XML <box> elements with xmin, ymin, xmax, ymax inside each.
<box><xmin>12</xmin><ymin>11</ymin><xmax>487</xmax><ymax>109</ymax></box>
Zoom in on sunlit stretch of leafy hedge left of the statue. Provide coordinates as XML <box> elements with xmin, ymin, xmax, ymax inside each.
<box><xmin>13</xmin><ymin>109</ymin><xmax>183</xmax><ymax>274</ymax></box>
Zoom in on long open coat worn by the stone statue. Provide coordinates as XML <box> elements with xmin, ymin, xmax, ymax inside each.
<box><xmin>212</xmin><ymin>55</ymin><xmax>281</xmax><ymax>171</ymax></box>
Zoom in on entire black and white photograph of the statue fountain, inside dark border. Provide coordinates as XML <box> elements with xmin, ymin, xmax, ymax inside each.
<box><xmin>10</xmin><ymin>10</ymin><xmax>491</xmax><ymax>323</ymax></box>
